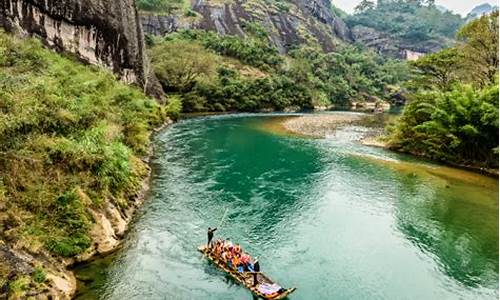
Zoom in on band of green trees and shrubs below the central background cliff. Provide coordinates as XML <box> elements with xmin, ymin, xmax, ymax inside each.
<box><xmin>149</xmin><ymin>27</ymin><xmax>408</xmax><ymax>112</ymax></box>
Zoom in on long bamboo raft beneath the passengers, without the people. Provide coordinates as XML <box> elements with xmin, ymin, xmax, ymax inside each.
<box><xmin>198</xmin><ymin>245</ymin><xmax>296</xmax><ymax>300</ymax></box>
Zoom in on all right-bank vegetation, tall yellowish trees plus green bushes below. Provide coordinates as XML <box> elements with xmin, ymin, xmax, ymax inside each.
<box><xmin>390</xmin><ymin>11</ymin><xmax>499</xmax><ymax>168</ymax></box>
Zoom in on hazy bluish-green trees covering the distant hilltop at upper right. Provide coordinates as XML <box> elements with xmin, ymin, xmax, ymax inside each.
<box><xmin>346</xmin><ymin>0</ymin><xmax>463</xmax><ymax>44</ymax></box>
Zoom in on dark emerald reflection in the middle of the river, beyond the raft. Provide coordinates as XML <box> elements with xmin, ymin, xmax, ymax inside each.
<box><xmin>158</xmin><ymin>117</ymin><xmax>323</xmax><ymax>248</ymax></box>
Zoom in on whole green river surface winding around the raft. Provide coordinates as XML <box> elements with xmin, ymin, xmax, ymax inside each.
<box><xmin>77</xmin><ymin>115</ymin><xmax>499</xmax><ymax>300</ymax></box>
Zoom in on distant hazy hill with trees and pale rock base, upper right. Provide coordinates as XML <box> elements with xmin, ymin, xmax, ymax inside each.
<box><xmin>346</xmin><ymin>1</ymin><xmax>464</xmax><ymax>59</ymax></box>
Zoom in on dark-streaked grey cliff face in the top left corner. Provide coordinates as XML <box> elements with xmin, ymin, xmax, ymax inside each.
<box><xmin>0</xmin><ymin>0</ymin><xmax>146</xmax><ymax>86</ymax></box>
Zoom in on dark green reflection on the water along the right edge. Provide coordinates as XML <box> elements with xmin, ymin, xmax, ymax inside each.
<box><xmin>396</xmin><ymin>168</ymin><xmax>498</xmax><ymax>288</ymax></box>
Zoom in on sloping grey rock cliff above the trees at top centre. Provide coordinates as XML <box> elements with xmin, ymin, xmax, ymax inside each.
<box><xmin>142</xmin><ymin>0</ymin><xmax>350</xmax><ymax>53</ymax></box>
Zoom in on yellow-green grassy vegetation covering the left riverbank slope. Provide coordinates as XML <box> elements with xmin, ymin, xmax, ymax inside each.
<box><xmin>0</xmin><ymin>32</ymin><xmax>178</xmax><ymax>292</ymax></box>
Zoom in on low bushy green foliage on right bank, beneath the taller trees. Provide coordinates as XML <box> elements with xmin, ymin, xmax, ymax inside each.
<box><xmin>391</xmin><ymin>83</ymin><xmax>498</xmax><ymax>168</ymax></box>
